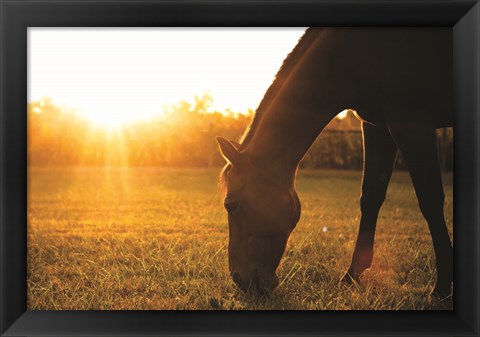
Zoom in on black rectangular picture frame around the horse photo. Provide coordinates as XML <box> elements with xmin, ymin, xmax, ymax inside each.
<box><xmin>0</xmin><ymin>0</ymin><xmax>480</xmax><ymax>336</ymax></box>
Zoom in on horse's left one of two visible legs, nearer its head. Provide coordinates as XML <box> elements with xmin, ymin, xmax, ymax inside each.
<box><xmin>342</xmin><ymin>123</ymin><xmax>397</xmax><ymax>283</ymax></box>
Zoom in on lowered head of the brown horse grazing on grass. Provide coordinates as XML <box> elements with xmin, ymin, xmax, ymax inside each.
<box><xmin>217</xmin><ymin>137</ymin><xmax>300</xmax><ymax>293</ymax></box>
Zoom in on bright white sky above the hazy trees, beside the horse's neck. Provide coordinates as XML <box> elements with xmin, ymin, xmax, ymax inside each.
<box><xmin>28</xmin><ymin>28</ymin><xmax>305</xmax><ymax>127</ymax></box>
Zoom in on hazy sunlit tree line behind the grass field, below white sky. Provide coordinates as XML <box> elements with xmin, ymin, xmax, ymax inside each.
<box><xmin>27</xmin><ymin>94</ymin><xmax>453</xmax><ymax>169</ymax></box>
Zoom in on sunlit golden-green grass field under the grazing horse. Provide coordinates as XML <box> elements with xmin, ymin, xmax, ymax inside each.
<box><xmin>28</xmin><ymin>168</ymin><xmax>453</xmax><ymax>310</ymax></box>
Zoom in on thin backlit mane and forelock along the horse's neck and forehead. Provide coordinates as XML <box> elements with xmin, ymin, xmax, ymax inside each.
<box><xmin>220</xmin><ymin>28</ymin><xmax>315</xmax><ymax>189</ymax></box>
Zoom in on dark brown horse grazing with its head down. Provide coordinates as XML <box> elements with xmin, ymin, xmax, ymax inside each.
<box><xmin>217</xmin><ymin>28</ymin><xmax>453</xmax><ymax>297</ymax></box>
